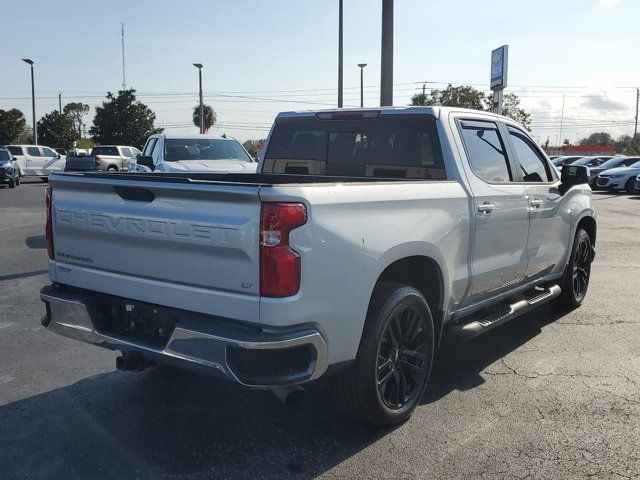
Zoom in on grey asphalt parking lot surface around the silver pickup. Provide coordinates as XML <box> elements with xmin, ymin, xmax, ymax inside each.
<box><xmin>0</xmin><ymin>177</ymin><xmax>640</xmax><ymax>479</ymax></box>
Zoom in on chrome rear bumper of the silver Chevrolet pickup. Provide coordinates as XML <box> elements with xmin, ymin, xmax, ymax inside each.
<box><xmin>40</xmin><ymin>286</ymin><xmax>327</xmax><ymax>388</ymax></box>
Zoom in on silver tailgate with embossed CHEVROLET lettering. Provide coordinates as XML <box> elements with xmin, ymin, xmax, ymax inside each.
<box><xmin>50</xmin><ymin>175</ymin><xmax>260</xmax><ymax>322</ymax></box>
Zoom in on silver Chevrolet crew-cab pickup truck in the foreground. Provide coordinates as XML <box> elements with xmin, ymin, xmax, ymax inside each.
<box><xmin>41</xmin><ymin>107</ymin><xmax>596</xmax><ymax>425</ymax></box>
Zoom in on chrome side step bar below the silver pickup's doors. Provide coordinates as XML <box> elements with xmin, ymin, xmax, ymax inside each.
<box><xmin>450</xmin><ymin>285</ymin><xmax>561</xmax><ymax>339</ymax></box>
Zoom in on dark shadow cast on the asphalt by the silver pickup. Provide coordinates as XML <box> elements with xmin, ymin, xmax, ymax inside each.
<box><xmin>0</xmin><ymin>307</ymin><xmax>562</xmax><ymax>478</ymax></box>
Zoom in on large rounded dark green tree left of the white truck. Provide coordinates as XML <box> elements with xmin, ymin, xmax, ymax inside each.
<box><xmin>89</xmin><ymin>89</ymin><xmax>160</xmax><ymax>148</ymax></box>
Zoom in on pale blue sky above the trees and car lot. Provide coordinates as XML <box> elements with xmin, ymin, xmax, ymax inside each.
<box><xmin>0</xmin><ymin>0</ymin><xmax>640</xmax><ymax>143</ymax></box>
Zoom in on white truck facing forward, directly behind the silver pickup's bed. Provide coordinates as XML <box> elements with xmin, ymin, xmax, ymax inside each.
<box><xmin>135</xmin><ymin>133</ymin><xmax>258</xmax><ymax>173</ymax></box>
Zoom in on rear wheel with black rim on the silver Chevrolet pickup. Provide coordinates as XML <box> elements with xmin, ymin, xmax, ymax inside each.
<box><xmin>332</xmin><ymin>283</ymin><xmax>434</xmax><ymax>427</ymax></box>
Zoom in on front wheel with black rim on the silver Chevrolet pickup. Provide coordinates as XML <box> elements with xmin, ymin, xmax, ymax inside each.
<box><xmin>556</xmin><ymin>228</ymin><xmax>593</xmax><ymax>308</ymax></box>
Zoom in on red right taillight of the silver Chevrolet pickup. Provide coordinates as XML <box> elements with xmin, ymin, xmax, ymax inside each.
<box><xmin>260</xmin><ymin>203</ymin><xmax>307</xmax><ymax>297</ymax></box>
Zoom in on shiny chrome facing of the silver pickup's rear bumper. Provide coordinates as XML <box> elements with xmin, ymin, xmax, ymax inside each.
<box><xmin>40</xmin><ymin>287</ymin><xmax>327</xmax><ymax>388</ymax></box>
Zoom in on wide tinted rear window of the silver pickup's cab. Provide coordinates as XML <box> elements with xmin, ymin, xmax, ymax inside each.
<box><xmin>263</xmin><ymin>115</ymin><xmax>446</xmax><ymax>180</ymax></box>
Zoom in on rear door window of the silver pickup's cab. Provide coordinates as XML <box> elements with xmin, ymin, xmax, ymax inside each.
<box><xmin>460</xmin><ymin>120</ymin><xmax>513</xmax><ymax>183</ymax></box>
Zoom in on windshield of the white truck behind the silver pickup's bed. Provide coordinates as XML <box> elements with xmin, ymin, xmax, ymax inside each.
<box><xmin>164</xmin><ymin>138</ymin><xmax>252</xmax><ymax>162</ymax></box>
